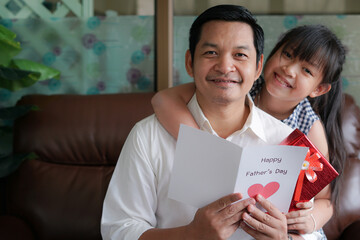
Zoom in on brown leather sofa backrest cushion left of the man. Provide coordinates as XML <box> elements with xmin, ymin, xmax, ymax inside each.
<box><xmin>14</xmin><ymin>93</ymin><xmax>153</xmax><ymax>165</ymax></box>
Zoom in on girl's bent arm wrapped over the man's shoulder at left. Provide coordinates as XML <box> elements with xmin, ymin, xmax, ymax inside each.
<box><xmin>151</xmin><ymin>83</ymin><xmax>199</xmax><ymax>138</ymax></box>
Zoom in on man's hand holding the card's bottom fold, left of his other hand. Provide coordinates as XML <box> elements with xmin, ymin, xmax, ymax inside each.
<box><xmin>186</xmin><ymin>193</ymin><xmax>255</xmax><ymax>240</ymax></box>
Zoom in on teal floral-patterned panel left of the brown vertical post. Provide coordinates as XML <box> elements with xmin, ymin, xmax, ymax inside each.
<box><xmin>0</xmin><ymin>16</ymin><xmax>154</xmax><ymax>107</ymax></box>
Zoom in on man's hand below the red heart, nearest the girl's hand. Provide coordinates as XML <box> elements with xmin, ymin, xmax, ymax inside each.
<box><xmin>241</xmin><ymin>195</ymin><xmax>288</xmax><ymax>240</ymax></box>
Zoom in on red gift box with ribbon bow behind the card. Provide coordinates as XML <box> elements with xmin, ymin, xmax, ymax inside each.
<box><xmin>280</xmin><ymin>129</ymin><xmax>339</xmax><ymax>212</ymax></box>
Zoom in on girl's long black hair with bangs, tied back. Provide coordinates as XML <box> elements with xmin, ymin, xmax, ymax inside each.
<box><xmin>268</xmin><ymin>25</ymin><xmax>347</xmax><ymax>206</ymax></box>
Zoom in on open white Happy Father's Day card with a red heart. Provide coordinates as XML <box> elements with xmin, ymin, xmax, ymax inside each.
<box><xmin>168</xmin><ymin>125</ymin><xmax>308</xmax><ymax>212</ymax></box>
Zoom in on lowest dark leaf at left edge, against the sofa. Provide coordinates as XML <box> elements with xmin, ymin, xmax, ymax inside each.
<box><xmin>0</xmin><ymin>153</ymin><xmax>37</xmax><ymax>178</ymax></box>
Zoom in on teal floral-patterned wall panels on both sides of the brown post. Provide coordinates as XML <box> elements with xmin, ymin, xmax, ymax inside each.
<box><xmin>0</xmin><ymin>15</ymin><xmax>360</xmax><ymax>107</ymax></box>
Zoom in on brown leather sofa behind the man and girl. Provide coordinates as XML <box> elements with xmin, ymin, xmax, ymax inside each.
<box><xmin>0</xmin><ymin>93</ymin><xmax>360</xmax><ymax>240</ymax></box>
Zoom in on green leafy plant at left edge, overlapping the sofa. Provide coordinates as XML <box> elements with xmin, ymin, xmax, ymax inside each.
<box><xmin>0</xmin><ymin>25</ymin><xmax>60</xmax><ymax>178</ymax></box>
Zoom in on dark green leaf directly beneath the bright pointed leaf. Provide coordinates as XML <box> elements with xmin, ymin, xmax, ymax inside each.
<box><xmin>0</xmin><ymin>66</ymin><xmax>40</xmax><ymax>91</ymax></box>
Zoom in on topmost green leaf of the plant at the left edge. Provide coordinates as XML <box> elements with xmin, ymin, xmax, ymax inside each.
<box><xmin>0</xmin><ymin>25</ymin><xmax>21</xmax><ymax>66</ymax></box>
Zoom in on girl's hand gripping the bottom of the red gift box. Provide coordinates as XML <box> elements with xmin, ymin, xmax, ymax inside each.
<box><xmin>286</xmin><ymin>201</ymin><xmax>316</xmax><ymax>234</ymax></box>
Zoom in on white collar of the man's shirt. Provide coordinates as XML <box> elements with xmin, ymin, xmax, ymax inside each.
<box><xmin>188</xmin><ymin>94</ymin><xmax>266</xmax><ymax>141</ymax></box>
